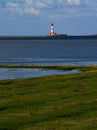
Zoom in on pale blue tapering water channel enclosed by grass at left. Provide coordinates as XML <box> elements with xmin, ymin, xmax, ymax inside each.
<box><xmin>0</xmin><ymin>68</ymin><xmax>80</xmax><ymax>80</ymax></box>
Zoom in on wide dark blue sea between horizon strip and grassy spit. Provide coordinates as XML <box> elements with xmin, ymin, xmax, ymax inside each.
<box><xmin>0</xmin><ymin>39</ymin><xmax>97</xmax><ymax>65</ymax></box>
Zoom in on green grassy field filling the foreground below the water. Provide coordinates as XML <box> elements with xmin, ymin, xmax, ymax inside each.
<box><xmin>0</xmin><ymin>66</ymin><xmax>97</xmax><ymax>130</ymax></box>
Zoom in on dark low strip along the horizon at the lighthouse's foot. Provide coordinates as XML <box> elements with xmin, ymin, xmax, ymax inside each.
<box><xmin>0</xmin><ymin>34</ymin><xmax>97</xmax><ymax>40</ymax></box>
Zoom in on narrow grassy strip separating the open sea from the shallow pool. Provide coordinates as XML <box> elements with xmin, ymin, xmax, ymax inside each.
<box><xmin>0</xmin><ymin>64</ymin><xmax>97</xmax><ymax>71</ymax></box>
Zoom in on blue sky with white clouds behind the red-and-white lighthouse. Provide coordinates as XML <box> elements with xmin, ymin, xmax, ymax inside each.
<box><xmin>0</xmin><ymin>0</ymin><xmax>97</xmax><ymax>35</ymax></box>
